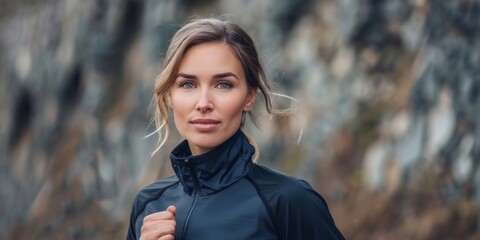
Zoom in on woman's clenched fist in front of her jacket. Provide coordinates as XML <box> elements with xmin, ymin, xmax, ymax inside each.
<box><xmin>141</xmin><ymin>206</ymin><xmax>177</xmax><ymax>240</ymax></box>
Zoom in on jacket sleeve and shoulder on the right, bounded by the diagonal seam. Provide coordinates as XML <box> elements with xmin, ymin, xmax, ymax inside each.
<box><xmin>247</xmin><ymin>165</ymin><xmax>343</xmax><ymax>239</ymax></box>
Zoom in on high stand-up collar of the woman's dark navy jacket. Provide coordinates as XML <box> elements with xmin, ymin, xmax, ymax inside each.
<box><xmin>170</xmin><ymin>130</ymin><xmax>255</xmax><ymax>195</ymax></box>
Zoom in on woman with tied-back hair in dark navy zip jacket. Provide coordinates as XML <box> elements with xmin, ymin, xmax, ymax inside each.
<box><xmin>127</xmin><ymin>19</ymin><xmax>343</xmax><ymax>240</ymax></box>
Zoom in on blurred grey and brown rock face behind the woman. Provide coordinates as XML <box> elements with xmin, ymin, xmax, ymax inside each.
<box><xmin>0</xmin><ymin>0</ymin><xmax>480</xmax><ymax>239</ymax></box>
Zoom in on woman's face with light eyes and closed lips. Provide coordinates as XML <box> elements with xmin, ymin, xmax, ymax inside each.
<box><xmin>169</xmin><ymin>42</ymin><xmax>256</xmax><ymax>155</ymax></box>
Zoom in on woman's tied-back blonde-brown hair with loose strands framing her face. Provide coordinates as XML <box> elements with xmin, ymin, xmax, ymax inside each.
<box><xmin>152</xmin><ymin>18</ymin><xmax>278</xmax><ymax>161</ymax></box>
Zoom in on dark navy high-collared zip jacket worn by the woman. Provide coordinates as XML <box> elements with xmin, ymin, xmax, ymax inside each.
<box><xmin>127</xmin><ymin>131</ymin><xmax>344</xmax><ymax>240</ymax></box>
